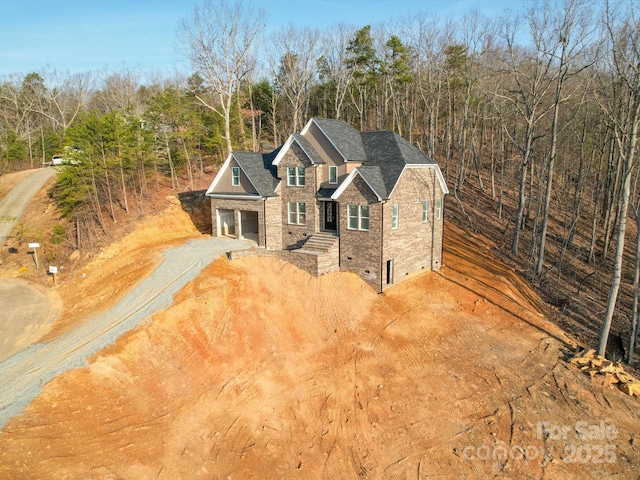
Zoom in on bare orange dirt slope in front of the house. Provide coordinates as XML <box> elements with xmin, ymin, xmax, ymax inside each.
<box><xmin>0</xmin><ymin>216</ymin><xmax>640</xmax><ymax>479</ymax></box>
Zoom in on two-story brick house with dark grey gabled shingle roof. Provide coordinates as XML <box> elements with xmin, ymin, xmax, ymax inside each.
<box><xmin>206</xmin><ymin>117</ymin><xmax>449</xmax><ymax>292</ymax></box>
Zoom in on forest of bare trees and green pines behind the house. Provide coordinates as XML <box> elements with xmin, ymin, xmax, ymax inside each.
<box><xmin>0</xmin><ymin>0</ymin><xmax>640</xmax><ymax>362</ymax></box>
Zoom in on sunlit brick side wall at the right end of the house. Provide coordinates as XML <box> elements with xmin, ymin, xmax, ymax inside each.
<box><xmin>383</xmin><ymin>168</ymin><xmax>444</xmax><ymax>288</ymax></box>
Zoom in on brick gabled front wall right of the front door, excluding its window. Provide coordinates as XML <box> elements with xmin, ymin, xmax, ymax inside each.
<box><xmin>339</xmin><ymin>176</ymin><xmax>383</xmax><ymax>291</ymax></box>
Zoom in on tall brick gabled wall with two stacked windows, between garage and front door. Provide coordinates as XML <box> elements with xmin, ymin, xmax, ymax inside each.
<box><xmin>278</xmin><ymin>142</ymin><xmax>319</xmax><ymax>249</ymax></box>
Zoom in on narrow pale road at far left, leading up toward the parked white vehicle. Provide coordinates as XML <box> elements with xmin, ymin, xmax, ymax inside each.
<box><xmin>0</xmin><ymin>168</ymin><xmax>56</xmax><ymax>247</ymax></box>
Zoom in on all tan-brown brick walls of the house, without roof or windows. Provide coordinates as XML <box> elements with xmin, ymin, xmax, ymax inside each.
<box><xmin>211</xmin><ymin>123</ymin><xmax>445</xmax><ymax>292</ymax></box>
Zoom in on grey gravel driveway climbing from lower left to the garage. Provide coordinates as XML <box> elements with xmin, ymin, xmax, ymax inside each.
<box><xmin>0</xmin><ymin>238</ymin><xmax>254</xmax><ymax>428</ymax></box>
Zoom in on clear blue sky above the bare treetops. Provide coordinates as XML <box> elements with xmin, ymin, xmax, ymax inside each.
<box><xmin>0</xmin><ymin>0</ymin><xmax>522</xmax><ymax>78</ymax></box>
